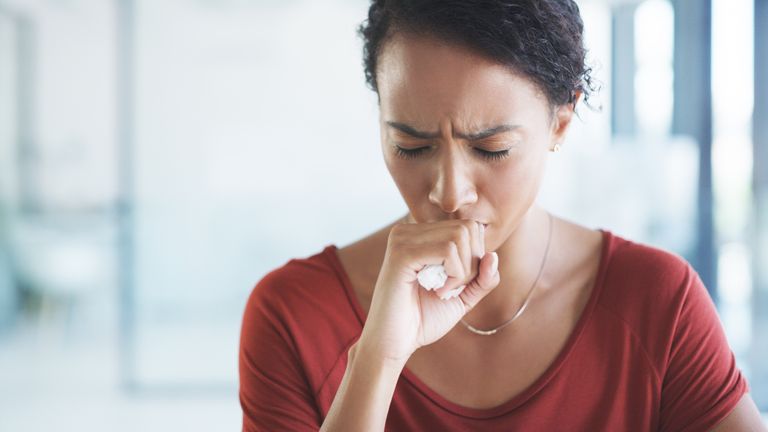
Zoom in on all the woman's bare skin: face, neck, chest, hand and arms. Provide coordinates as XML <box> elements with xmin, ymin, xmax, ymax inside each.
<box><xmin>323</xmin><ymin>34</ymin><xmax>764</xmax><ymax>430</ymax></box>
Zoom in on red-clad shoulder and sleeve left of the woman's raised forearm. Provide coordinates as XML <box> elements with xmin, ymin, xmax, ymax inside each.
<box><xmin>238</xmin><ymin>246</ymin><xmax>354</xmax><ymax>430</ymax></box>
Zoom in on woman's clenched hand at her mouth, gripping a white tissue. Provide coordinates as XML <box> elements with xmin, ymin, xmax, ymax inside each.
<box><xmin>360</xmin><ymin>220</ymin><xmax>500</xmax><ymax>365</ymax></box>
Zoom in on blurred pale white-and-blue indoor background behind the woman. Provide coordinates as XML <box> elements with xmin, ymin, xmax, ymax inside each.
<box><xmin>0</xmin><ymin>0</ymin><xmax>768</xmax><ymax>431</ymax></box>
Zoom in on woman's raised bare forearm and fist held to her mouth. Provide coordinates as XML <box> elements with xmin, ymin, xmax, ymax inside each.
<box><xmin>320</xmin><ymin>220</ymin><xmax>500</xmax><ymax>431</ymax></box>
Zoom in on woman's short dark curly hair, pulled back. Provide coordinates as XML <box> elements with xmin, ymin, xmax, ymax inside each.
<box><xmin>358</xmin><ymin>0</ymin><xmax>594</xmax><ymax>106</ymax></box>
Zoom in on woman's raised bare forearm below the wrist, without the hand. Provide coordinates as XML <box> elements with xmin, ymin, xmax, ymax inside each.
<box><xmin>320</xmin><ymin>341</ymin><xmax>405</xmax><ymax>432</ymax></box>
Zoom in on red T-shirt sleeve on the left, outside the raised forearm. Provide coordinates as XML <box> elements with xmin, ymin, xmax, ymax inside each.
<box><xmin>239</xmin><ymin>279</ymin><xmax>321</xmax><ymax>432</ymax></box>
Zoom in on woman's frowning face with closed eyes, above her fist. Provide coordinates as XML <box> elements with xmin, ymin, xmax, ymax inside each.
<box><xmin>377</xmin><ymin>34</ymin><xmax>573</xmax><ymax>250</ymax></box>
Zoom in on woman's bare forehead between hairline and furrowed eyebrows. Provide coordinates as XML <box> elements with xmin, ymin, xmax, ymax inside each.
<box><xmin>377</xmin><ymin>34</ymin><xmax>547</xmax><ymax>126</ymax></box>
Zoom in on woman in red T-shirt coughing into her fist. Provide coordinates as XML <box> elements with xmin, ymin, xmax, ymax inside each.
<box><xmin>240</xmin><ymin>0</ymin><xmax>765</xmax><ymax>431</ymax></box>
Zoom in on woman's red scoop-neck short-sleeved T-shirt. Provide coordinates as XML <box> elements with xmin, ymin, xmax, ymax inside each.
<box><xmin>239</xmin><ymin>230</ymin><xmax>749</xmax><ymax>431</ymax></box>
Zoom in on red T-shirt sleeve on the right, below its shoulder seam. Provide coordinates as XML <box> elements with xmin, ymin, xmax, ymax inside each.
<box><xmin>659</xmin><ymin>265</ymin><xmax>749</xmax><ymax>431</ymax></box>
